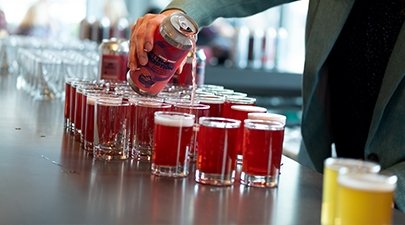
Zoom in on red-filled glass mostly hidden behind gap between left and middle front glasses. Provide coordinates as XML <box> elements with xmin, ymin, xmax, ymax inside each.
<box><xmin>173</xmin><ymin>103</ymin><xmax>210</xmax><ymax>161</ymax></box>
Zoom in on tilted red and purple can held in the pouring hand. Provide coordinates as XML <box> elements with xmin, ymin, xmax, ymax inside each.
<box><xmin>127</xmin><ymin>13</ymin><xmax>198</xmax><ymax>96</ymax></box>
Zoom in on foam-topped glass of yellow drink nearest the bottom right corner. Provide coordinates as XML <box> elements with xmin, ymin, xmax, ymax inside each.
<box><xmin>335</xmin><ymin>173</ymin><xmax>397</xmax><ymax>225</ymax></box>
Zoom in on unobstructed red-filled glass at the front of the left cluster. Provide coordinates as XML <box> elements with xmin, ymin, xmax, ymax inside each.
<box><xmin>94</xmin><ymin>98</ymin><xmax>130</xmax><ymax>160</ymax></box>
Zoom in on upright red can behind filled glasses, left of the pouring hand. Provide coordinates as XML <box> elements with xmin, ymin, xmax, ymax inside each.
<box><xmin>98</xmin><ymin>38</ymin><xmax>129</xmax><ymax>81</ymax></box>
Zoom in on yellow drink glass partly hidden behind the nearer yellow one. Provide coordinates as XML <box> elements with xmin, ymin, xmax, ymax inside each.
<box><xmin>321</xmin><ymin>158</ymin><xmax>380</xmax><ymax>225</ymax></box>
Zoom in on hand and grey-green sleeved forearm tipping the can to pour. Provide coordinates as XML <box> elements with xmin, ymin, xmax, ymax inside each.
<box><xmin>129</xmin><ymin>0</ymin><xmax>294</xmax><ymax>70</ymax></box>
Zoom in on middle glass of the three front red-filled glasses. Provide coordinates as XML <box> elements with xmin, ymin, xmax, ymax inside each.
<box><xmin>195</xmin><ymin>117</ymin><xmax>242</xmax><ymax>186</ymax></box>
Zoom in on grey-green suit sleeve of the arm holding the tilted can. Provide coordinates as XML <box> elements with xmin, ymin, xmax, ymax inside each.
<box><xmin>165</xmin><ymin>0</ymin><xmax>295</xmax><ymax>27</ymax></box>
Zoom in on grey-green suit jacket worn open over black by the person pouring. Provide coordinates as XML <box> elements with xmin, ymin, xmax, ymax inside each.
<box><xmin>168</xmin><ymin>0</ymin><xmax>405</xmax><ymax>211</ymax></box>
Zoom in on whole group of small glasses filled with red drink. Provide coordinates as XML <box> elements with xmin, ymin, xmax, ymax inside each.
<box><xmin>65</xmin><ymin>80</ymin><xmax>286</xmax><ymax>187</ymax></box>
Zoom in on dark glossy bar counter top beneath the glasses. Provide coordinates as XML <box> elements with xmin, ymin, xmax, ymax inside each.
<box><xmin>0</xmin><ymin>75</ymin><xmax>405</xmax><ymax>225</ymax></box>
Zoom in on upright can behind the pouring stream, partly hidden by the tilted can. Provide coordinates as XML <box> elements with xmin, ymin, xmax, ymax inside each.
<box><xmin>178</xmin><ymin>48</ymin><xmax>207</xmax><ymax>87</ymax></box>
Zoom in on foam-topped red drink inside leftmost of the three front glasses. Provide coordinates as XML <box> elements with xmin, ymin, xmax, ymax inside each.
<box><xmin>152</xmin><ymin>113</ymin><xmax>194</xmax><ymax>166</ymax></box>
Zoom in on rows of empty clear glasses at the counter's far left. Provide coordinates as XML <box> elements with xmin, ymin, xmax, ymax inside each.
<box><xmin>1</xmin><ymin>35</ymin><xmax>99</xmax><ymax>100</ymax></box>
